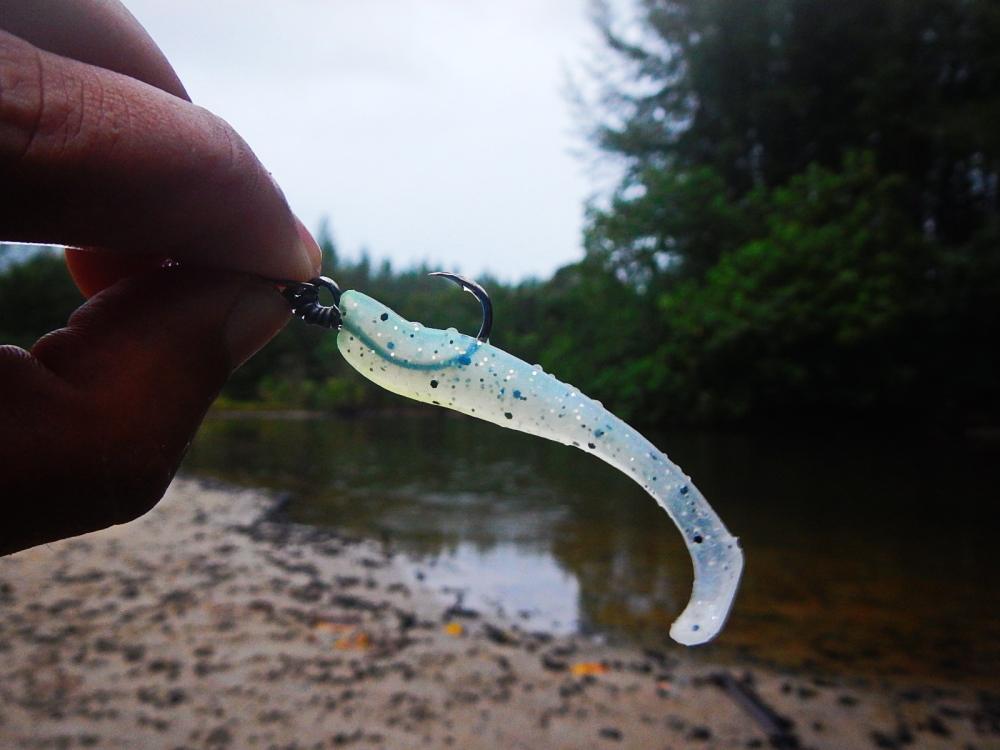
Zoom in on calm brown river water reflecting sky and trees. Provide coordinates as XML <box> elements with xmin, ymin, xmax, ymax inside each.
<box><xmin>185</xmin><ymin>416</ymin><xmax>1000</xmax><ymax>681</ymax></box>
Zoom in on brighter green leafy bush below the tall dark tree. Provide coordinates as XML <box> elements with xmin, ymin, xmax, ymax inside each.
<box><xmin>654</xmin><ymin>156</ymin><xmax>930</xmax><ymax>418</ymax></box>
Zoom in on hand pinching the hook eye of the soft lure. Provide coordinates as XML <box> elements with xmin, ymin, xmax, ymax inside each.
<box><xmin>0</xmin><ymin>0</ymin><xmax>319</xmax><ymax>554</ymax></box>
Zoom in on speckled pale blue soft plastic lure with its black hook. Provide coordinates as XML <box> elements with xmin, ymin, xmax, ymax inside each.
<box><xmin>284</xmin><ymin>273</ymin><xmax>743</xmax><ymax>646</ymax></box>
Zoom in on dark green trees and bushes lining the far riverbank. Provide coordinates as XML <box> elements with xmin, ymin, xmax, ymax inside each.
<box><xmin>0</xmin><ymin>0</ymin><xmax>1000</xmax><ymax>426</ymax></box>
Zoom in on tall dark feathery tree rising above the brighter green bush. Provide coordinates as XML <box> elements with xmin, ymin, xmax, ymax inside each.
<box><xmin>591</xmin><ymin>0</ymin><xmax>1000</xmax><ymax>244</ymax></box>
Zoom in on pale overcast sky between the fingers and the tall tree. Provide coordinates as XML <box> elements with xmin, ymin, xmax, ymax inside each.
<box><xmin>125</xmin><ymin>0</ymin><xmax>598</xmax><ymax>279</ymax></box>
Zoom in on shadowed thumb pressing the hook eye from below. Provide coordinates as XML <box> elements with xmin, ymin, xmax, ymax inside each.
<box><xmin>0</xmin><ymin>269</ymin><xmax>288</xmax><ymax>553</ymax></box>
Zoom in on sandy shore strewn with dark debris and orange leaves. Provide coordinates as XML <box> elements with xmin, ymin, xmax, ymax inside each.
<box><xmin>0</xmin><ymin>480</ymin><xmax>1000</xmax><ymax>750</ymax></box>
